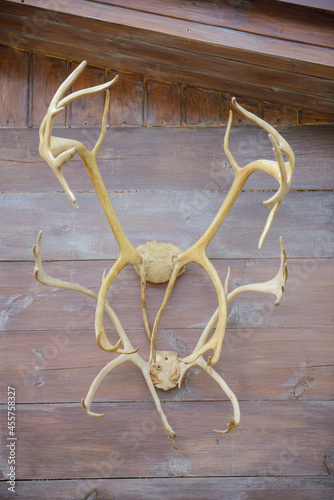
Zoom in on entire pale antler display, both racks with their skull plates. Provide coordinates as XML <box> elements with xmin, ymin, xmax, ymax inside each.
<box><xmin>33</xmin><ymin>61</ymin><xmax>295</xmax><ymax>447</ymax></box>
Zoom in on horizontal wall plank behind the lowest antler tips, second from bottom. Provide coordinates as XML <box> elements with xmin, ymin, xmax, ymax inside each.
<box><xmin>1</xmin><ymin>400</ymin><xmax>334</xmax><ymax>479</ymax></box>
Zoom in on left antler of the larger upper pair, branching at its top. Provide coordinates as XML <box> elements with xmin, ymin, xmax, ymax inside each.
<box><xmin>39</xmin><ymin>61</ymin><xmax>144</xmax><ymax>348</ymax></box>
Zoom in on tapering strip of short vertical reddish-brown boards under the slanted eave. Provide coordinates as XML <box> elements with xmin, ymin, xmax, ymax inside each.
<box><xmin>0</xmin><ymin>46</ymin><xmax>334</xmax><ymax>128</ymax></box>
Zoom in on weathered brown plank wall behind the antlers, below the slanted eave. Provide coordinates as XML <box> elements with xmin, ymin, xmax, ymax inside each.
<box><xmin>0</xmin><ymin>47</ymin><xmax>334</xmax><ymax>500</ymax></box>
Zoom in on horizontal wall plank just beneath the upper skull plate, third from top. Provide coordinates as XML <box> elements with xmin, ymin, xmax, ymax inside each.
<box><xmin>0</xmin><ymin>259</ymin><xmax>334</xmax><ymax>337</ymax></box>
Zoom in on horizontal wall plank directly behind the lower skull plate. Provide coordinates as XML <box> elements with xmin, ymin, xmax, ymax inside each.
<box><xmin>0</xmin><ymin>326</ymin><xmax>334</xmax><ymax>404</ymax></box>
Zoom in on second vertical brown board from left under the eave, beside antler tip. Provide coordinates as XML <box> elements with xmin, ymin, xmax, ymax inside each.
<box><xmin>31</xmin><ymin>54</ymin><xmax>67</xmax><ymax>127</ymax></box>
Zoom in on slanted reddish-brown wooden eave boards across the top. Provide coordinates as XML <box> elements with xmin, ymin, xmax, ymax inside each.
<box><xmin>0</xmin><ymin>0</ymin><xmax>333</xmax><ymax>113</ymax></box>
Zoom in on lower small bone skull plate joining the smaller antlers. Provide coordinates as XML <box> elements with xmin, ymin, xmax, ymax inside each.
<box><xmin>150</xmin><ymin>351</ymin><xmax>180</xmax><ymax>391</ymax></box>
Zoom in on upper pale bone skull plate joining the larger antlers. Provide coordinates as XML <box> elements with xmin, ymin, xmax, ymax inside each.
<box><xmin>136</xmin><ymin>241</ymin><xmax>185</xmax><ymax>283</ymax></box>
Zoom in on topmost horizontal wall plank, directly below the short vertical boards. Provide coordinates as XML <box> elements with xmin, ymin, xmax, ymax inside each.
<box><xmin>0</xmin><ymin>126</ymin><xmax>334</xmax><ymax>193</ymax></box>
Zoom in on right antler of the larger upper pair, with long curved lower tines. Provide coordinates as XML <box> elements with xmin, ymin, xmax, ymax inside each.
<box><xmin>150</xmin><ymin>98</ymin><xmax>295</xmax><ymax>365</ymax></box>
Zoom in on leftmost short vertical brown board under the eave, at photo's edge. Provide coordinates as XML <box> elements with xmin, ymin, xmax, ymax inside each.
<box><xmin>0</xmin><ymin>47</ymin><xmax>29</xmax><ymax>127</ymax></box>
